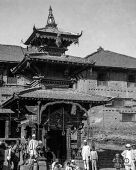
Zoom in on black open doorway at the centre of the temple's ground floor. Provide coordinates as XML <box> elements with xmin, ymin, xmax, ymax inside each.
<box><xmin>47</xmin><ymin>130</ymin><xmax>67</xmax><ymax>163</ymax></box>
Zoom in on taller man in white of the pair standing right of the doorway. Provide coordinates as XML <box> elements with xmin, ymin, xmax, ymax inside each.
<box><xmin>82</xmin><ymin>140</ymin><xmax>91</xmax><ymax>170</ymax></box>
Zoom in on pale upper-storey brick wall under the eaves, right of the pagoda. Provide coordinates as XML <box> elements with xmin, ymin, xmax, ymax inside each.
<box><xmin>77</xmin><ymin>70</ymin><xmax>136</xmax><ymax>98</ymax></box>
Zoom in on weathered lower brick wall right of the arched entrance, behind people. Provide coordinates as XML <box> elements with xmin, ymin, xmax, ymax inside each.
<box><xmin>85</xmin><ymin>106</ymin><xmax>136</xmax><ymax>145</ymax></box>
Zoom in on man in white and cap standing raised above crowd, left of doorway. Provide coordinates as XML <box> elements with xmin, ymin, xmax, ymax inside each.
<box><xmin>28</xmin><ymin>134</ymin><xmax>38</xmax><ymax>159</ymax></box>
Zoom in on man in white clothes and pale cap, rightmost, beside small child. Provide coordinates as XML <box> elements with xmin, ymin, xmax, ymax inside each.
<box><xmin>121</xmin><ymin>144</ymin><xmax>135</xmax><ymax>170</ymax></box>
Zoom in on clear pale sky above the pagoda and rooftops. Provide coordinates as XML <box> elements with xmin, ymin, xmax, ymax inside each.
<box><xmin>0</xmin><ymin>0</ymin><xmax>136</xmax><ymax>57</ymax></box>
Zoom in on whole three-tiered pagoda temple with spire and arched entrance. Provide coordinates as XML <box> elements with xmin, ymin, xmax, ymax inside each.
<box><xmin>2</xmin><ymin>7</ymin><xmax>109</xmax><ymax>162</ymax></box>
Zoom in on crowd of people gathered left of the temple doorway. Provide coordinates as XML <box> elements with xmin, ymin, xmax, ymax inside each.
<box><xmin>0</xmin><ymin>134</ymin><xmax>42</xmax><ymax>170</ymax></box>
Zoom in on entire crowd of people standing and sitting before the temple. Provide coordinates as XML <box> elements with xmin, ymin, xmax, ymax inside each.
<box><xmin>0</xmin><ymin>134</ymin><xmax>136</xmax><ymax>170</ymax></box>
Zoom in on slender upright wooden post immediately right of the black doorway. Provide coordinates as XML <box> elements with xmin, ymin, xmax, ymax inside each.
<box><xmin>66</xmin><ymin>127</ymin><xmax>71</xmax><ymax>160</ymax></box>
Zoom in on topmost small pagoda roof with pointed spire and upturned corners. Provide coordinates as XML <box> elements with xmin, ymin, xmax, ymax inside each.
<box><xmin>25</xmin><ymin>7</ymin><xmax>82</xmax><ymax>56</ymax></box>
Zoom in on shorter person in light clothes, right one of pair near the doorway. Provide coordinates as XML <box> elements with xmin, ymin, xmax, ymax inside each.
<box><xmin>91</xmin><ymin>146</ymin><xmax>98</xmax><ymax>170</ymax></box>
